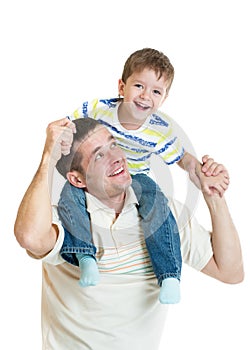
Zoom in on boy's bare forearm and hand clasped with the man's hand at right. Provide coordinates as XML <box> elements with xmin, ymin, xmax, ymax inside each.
<box><xmin>177</xmin><ymin>152</ymin><xmax>229</xmax><ymax>196</ymax></box>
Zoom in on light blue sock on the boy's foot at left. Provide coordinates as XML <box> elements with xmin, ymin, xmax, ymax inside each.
<box><xmin>76</xmin><ymin>254</ymin><xmax>100</xmax><ymax>287</ymax></box>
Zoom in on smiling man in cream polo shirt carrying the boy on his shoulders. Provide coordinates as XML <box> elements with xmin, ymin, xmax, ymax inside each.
<box><xmin>15</xmin><ymin>119</ymin><xmax>243</xmax><ymax>350</ymax></box>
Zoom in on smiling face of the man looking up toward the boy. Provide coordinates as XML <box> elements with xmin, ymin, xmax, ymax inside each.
<box><xmin>76</xmin><ymin>126</ymin><xmax>131</xmax><ymax>201</ymax></box>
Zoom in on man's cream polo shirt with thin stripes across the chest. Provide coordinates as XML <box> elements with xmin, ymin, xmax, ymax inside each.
<box><xmin>42</xmin><ymin>189</ymin><xmax>213</xmax><ymax>350</ymax></box>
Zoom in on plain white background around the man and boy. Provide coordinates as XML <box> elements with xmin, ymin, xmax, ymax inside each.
<box><xmin>0</xmin><ymin>0</ymin><xmax>250</xmax><ymax>350</ymax></box>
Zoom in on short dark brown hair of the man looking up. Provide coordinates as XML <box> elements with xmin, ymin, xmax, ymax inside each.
<box><xmin>56</xmin><ymin>118</ymin><xmax>100</xmax><ymax>178</ymax></box>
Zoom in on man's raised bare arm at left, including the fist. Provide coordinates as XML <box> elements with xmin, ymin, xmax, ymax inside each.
<box><xmin>14</xmin><ymin>118</ymin><xmax>75</xmax><ymax>257</ymax></box>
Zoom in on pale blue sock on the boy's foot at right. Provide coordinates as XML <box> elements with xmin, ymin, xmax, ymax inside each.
<box><xmin>159</xmin><ymin>277</ymin><xmax>180</xmax><ymax>304</ymax></box>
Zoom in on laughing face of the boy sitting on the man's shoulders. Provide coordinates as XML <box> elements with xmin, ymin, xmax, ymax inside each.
<box><xmin>118</xmin><ymin>68</ymin><xmax>168</xmax><ymax>124</ymax></box>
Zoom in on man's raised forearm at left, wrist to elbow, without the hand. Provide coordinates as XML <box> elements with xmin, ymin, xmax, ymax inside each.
<box><xmin>14</xmin><ymin>153</ymin><xmax>56</xmax><ymax>255</ymax></box>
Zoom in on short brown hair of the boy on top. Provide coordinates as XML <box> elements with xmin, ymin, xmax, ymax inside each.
<box><xmin>122</xmin><ymin>48</ymin><xmax>174</xmax><ymax>93</ymax></box>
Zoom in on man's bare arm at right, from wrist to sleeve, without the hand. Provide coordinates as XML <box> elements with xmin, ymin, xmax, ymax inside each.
<box><xmin>202</xmin><ymin>191</ymin><xmax>244</xmax><ymax>284</ymax></box>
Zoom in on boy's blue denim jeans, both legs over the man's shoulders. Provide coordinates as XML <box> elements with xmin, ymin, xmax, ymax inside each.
<box><xmin>58</xmin><ymin>174</ymin><xmax>182</xmax><ymax>286</ymax></box>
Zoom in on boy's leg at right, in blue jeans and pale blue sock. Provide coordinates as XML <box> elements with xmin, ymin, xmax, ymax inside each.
<box><xmin>132</xmin><ymin>174</ymin><xmax>182</xmax><ymax>304</ymax></box>
